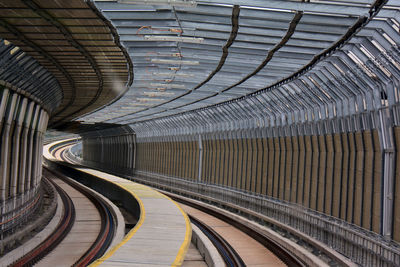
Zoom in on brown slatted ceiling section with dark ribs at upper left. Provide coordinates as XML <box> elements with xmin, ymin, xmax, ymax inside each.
<box><xmin>0</xmin><ymin>0</ymin><xmax>133</xmax><ymax>127</ymax></box>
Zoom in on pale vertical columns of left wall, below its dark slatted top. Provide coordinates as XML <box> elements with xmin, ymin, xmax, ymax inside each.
<box><xmin>0</xmin><ymin>84</ymin><xmax>49</xmax><ymax>238</ymax></box>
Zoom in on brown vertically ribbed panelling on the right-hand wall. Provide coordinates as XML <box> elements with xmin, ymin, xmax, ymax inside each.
<box><xmin>137</xmin><ymin>128</ymin><xmax>384</xmax><ymax>234</ymax></box>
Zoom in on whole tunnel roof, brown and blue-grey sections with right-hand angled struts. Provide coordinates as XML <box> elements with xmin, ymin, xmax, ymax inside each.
<box><xmin>0</xmin><ymin>0</ymin><xmax>400</xmax><ymax>134</ymax></box>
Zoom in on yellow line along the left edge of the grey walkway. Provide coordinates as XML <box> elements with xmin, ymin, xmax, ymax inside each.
<box><xmin>89</xmin><ymin>176</ymin><xmax>146</xmax><ymax>266</ymax></box>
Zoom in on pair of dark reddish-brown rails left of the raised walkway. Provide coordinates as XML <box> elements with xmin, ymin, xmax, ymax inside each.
<box><xmin>12</xmin><ymin>168</ymin><xmax>116</xmax><ymax>266</ymax></box>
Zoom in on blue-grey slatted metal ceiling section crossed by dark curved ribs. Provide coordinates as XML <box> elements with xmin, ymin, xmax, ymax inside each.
<box><xmin>78</xmin><ymin>0</ymin><xmax>398</xmax><ymax>129</ymax></box>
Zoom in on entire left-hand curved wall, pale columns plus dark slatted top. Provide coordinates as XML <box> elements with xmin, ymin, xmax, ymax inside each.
<box><xmin>0</xmin><ymin>39</ymin><xmax>63</xmax><ymax>242</ymax></box>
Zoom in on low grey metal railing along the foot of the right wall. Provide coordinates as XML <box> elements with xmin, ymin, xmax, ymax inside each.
<box><xmin>130</xmin><ymin>171</ymin><xmax>400</xmax><ymax>266</ymax></box>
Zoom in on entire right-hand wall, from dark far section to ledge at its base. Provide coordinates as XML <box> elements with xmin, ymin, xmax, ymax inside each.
<box><xmin>79</xmin><ymin>121</ymin><xmax>400</xmax><ymax>265</ymax></box>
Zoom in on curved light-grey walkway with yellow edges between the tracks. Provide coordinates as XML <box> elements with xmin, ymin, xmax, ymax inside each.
<box><xmin>44</xmin><ymin>143</ymin><xmax>192</xmax><ymax>267</ymax></box>
